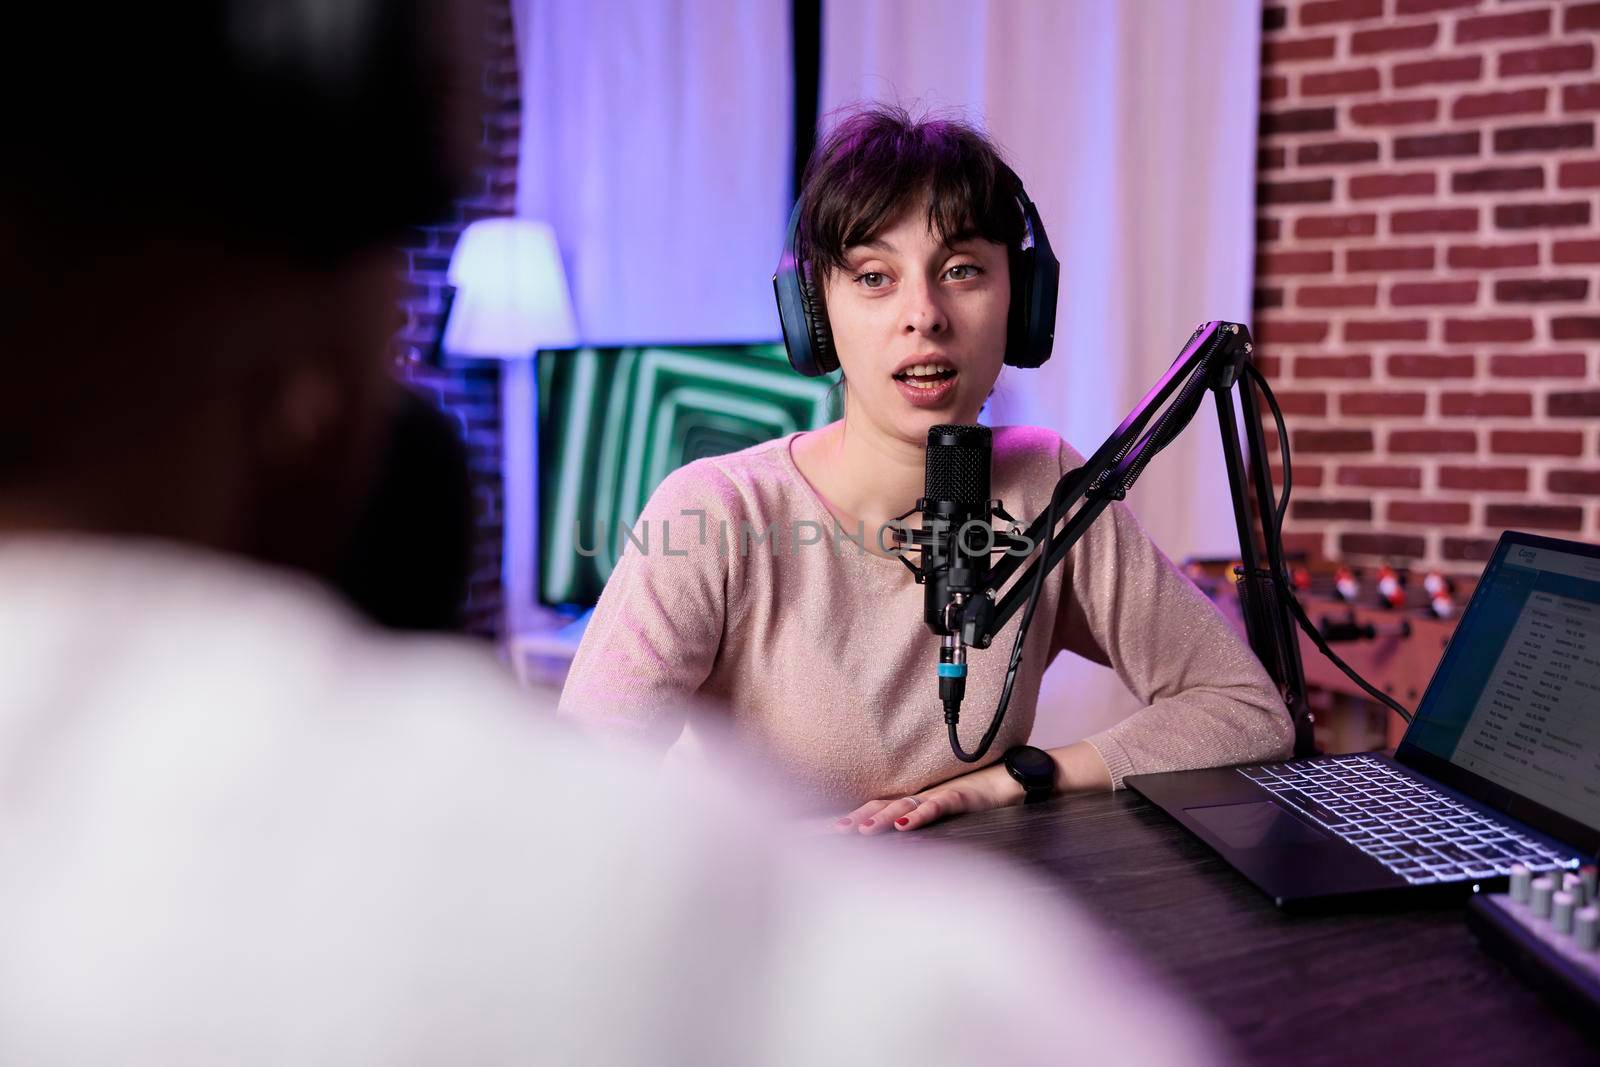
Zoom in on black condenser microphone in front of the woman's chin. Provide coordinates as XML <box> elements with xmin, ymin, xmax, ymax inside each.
<box><xmin>920</xmin><ymin>426</ymin><xmax>994</xmax><ymax>635</ymax></box>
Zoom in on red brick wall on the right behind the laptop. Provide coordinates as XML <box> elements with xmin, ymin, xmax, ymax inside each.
<box><xmin>1256</xmin><ymin>0</ymin><xmax>1600</xmax><ymax>571</ymax></box>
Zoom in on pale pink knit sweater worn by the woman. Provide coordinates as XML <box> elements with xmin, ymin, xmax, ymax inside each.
<box><xmin>560</xmin><ymin>427</ymin><xmax>1291</xmax><ymax>806</ymax></box>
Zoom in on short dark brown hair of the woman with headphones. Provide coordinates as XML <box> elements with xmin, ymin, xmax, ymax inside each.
<box><xmin>797</xmin><ymin>104</ymin><xmax>1026</xmax><ymax>282</ymax></box>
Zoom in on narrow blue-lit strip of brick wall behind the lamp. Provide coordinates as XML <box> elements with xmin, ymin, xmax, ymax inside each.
<box><xmin>395</xmin><ymin>0</ymin><xmax>522</xmax><ymax>637</ymax></box>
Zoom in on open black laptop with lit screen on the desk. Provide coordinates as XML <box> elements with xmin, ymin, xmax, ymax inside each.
<box><xmin>1126</xmin><ymin>533</ymin><xmax>1600</xmax><ymax>907</ymax></box>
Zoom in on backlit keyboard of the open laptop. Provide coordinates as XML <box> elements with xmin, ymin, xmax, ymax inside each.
<box><xmin>1238</xmin><ymin>755</ymin><xmax>1579</xmax><ymax>885</ymax></box>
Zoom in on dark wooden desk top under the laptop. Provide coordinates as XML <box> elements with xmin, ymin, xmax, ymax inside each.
<box><xmin>870</xmin><ymin>792</ymin><xmax>1600</xmax><ymax>1067</ymax></box>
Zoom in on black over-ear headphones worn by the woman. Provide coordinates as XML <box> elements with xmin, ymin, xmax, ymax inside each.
<box><xmin>773</xmin><ymin>174</ymin><xmax>1061</xmax><ymax>378</ymax></box>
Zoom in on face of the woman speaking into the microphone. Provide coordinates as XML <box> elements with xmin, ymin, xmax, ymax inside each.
<box><xmin>824</xmin><ymin>202</ymin><xmax>1011</xmax><ymax>446</ymax></box>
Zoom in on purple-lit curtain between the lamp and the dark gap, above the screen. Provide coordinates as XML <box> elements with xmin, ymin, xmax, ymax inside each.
<box><xmin>512</xmin><ymin>0</ymin><xmax>794</xmax><ymax>344</ymax></box>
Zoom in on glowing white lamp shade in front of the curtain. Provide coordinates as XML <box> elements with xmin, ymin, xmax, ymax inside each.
<box><xmin>445</xmin><ymin>219</ymin><xmax>578</xmax><ymax>360</ymax></box>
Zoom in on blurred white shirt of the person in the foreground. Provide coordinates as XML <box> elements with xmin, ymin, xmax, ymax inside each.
<box><xmin>0</xmin><ymin>537</ymin><xmax>1216</xmax><ymax>1067</ymax></box>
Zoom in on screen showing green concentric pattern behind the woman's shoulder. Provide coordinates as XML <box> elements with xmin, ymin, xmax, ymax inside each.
<box><xmin>539</xmin><ymin>344</ymin><xmax>835</xmax><ymax>606</ymax></box>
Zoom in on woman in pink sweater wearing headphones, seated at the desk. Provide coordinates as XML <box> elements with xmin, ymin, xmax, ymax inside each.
<box><xmin>562</xmin><ymin>106</ymin><xmax>1293</xmax><ymax>833</ymax></box>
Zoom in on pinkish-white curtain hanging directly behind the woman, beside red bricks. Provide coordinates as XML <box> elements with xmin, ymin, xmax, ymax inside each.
<box><xmin>822</xmin><ymin>0</ymin><xmax>1261</xmax><ymax>744</ymax></box>
